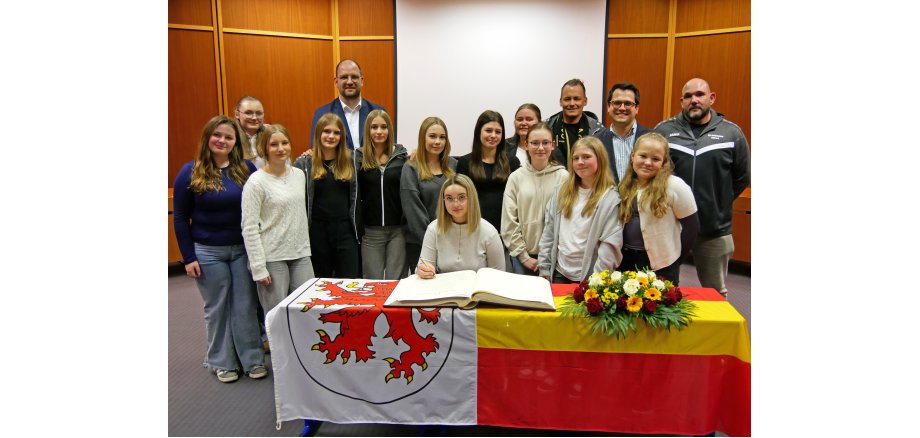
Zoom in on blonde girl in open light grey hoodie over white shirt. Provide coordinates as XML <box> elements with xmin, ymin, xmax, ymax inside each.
<box><xmin>537</xmin><ymin>137</ymin><xmax>623</xmax><ymax>283</ymax></box>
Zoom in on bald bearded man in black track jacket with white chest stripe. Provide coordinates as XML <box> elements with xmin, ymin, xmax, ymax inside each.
<box><xmin>655</xmin><ymin>78</ymin><xmax>751</xmax><ymax>296</ymax></box>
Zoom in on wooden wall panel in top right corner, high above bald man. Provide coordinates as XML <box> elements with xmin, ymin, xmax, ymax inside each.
<box><xmin>677</xmin><ymin>0</ymin><xmax>751</xmax><ymax>33</ymax></box>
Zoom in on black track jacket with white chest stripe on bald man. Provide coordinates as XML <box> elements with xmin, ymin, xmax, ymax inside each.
<box><xmin>655</xmin><ymin>109</ymin><xmax>751</xmax><ymax>238</ymax></box>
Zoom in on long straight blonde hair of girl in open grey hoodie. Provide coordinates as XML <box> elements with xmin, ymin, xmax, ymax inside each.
<box><xmin>559</xmin><ymin>137</ymin><xmax>614</xmax><ymax>218</ymax></box>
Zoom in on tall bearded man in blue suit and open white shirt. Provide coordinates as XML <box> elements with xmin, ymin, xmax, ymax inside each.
<box><xmin>310</xmin><ymin>59</ymin><xmax>386</xmax><ymax>150</ymax></box>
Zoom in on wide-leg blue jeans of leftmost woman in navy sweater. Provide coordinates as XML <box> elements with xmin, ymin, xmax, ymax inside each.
<box><xmin>195</xmin><ymin>243</ymin><xmax>264</xmax><ymax>372</ymax></box>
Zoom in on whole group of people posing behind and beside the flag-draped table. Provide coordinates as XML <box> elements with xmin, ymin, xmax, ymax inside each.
<box><xmin>174</xmin><ymin>60</ymin><xmax>750</xmax><ymax>382</ymax></box>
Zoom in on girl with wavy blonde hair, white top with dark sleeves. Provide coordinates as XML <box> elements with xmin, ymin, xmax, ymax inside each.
<box><xmin>618</xmin><ymin>132</ymin><xmax>700</xmax><ymax>284</ymax></box>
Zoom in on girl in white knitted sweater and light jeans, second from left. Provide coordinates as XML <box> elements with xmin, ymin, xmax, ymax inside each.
<box><xmin>243</xmin><ymin>125</ymin><xmax>313</xmax><ymax>314</ymax></box>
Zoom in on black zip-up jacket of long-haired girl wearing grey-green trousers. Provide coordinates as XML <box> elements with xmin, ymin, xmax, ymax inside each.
<box><xmin>355</xmin><ymin>144</ymin><xmax>409</xmax><ymax>228</ymax></box>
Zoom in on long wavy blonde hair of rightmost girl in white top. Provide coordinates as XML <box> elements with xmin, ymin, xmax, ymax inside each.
<box><xmin>618</xmin><ymin>132</ymin><xmax>674</xmax><ymax>224</ymax></box>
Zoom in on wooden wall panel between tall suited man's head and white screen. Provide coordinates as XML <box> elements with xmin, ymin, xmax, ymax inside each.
<box><xmin>341</xmin><ymin>41</ymin><xmax>398</xmax><ymax>129</ymax></box>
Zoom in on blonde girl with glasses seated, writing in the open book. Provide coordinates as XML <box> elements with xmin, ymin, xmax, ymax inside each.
<box><xmin>415</xmin><ymin>175</ymin><xmax>505</xmax><ymax>279</ymax></box>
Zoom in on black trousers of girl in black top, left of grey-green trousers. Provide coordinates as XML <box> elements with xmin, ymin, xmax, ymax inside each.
<box><xmin>310</xmin><ymin>219</ymin><xmax>361</xmax><ymax>278</ymax></box>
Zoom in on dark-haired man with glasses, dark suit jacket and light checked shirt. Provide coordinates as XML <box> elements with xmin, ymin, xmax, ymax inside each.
<box><xmin>592</xmin><ymin>82</ymin><xmax>651</xmax><ymax>184</ymax></box>
